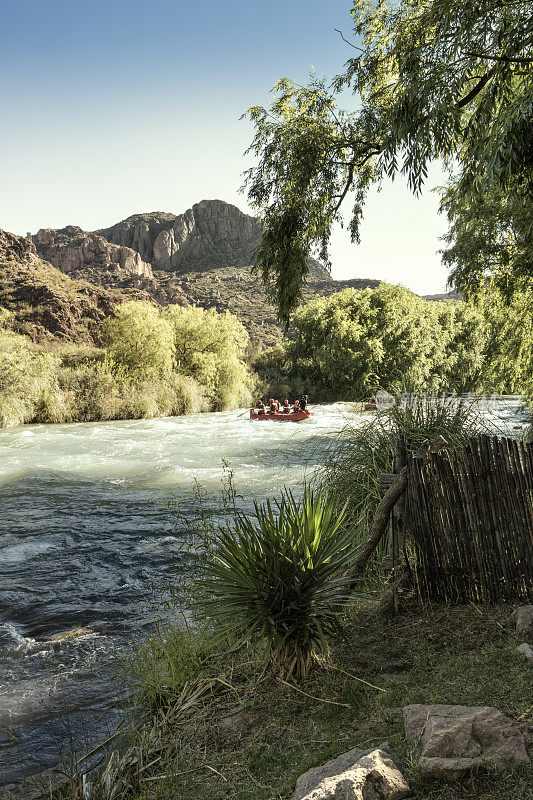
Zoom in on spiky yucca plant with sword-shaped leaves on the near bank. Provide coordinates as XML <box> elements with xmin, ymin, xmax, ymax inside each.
<box><xmin>194</xmin><ymin>487</ymin><xmax>353</xmax><ymax>679</ymax></box>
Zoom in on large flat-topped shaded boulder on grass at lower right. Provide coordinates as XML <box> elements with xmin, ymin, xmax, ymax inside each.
<box><xmin>403</xmin><ymin>705</ymin><xmax>530</xmax><ymax>780</ymax></box>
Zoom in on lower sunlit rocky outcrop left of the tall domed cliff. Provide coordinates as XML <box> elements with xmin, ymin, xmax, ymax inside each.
<box><xmin>33</xmin><ymin>225</ymin><xmax>153</xmax><ymax>283</ymax></box>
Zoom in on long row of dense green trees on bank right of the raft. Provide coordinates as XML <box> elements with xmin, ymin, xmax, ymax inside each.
<box><xmin>254</xmin><ymin>283</ymin><xmax>533</xmax><ymax>401</ymax></box>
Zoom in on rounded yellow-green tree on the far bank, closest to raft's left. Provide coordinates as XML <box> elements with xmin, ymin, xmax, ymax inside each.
<box><xmin>163</xmin><ymin>306</ymin><xmax>253</xmax><ymax>411</ymax></box>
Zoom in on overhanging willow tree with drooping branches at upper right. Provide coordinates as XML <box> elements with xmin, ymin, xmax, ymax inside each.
<box><xmin>245</xmin><ymin>0</ymin><xmax>533</xmax><ymax>321</ymax></box>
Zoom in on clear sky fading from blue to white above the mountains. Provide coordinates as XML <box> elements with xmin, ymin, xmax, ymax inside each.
<box><xmin>0</xmin><ymin>0</ymin><xmax>447</xmax><ymax>294</ymax></box>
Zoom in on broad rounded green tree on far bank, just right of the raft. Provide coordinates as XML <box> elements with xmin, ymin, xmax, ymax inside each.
<box><xmin>288</xmin><ymin>283</ymin><xmax>453</xmax><ymax>400</ymax></box>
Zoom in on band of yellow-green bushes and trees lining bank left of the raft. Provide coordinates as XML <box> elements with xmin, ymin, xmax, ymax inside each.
<box><xmin>0</xmin><ymin>301</ymin><xmax>254</xmax><ymax>426</ymax></box>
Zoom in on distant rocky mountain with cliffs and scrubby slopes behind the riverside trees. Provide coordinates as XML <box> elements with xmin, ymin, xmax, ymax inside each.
<box><xmin>33</xmin><ymin>200</ymin><xmax>378</xmax><ymax>346</ymax></box>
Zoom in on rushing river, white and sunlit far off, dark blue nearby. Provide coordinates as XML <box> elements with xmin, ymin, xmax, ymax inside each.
<box><xmin>0</xmin><ymin>402</ymin><xmax>517</xmax><ymax>796</ymax></box>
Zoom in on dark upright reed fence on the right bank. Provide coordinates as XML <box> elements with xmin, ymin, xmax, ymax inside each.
<box><xmin>405</xmin><ymin>436</ymin><xmax>533</xmax><ymax>603</ymax></box>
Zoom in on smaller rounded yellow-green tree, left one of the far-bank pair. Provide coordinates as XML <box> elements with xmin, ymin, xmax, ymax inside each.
<box><xmin>105</xmin><ymin>301</ymin><xmax>174</xmax><ymax>378</ymax></box>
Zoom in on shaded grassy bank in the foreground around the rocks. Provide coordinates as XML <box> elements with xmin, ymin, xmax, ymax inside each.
<box><xmin>72</xmin><ymin>603</ymin><xmax>533</xmax><ymax>800</ymax></box>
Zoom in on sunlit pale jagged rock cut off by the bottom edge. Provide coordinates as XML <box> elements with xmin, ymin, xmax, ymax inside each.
<box><xmin>292</xmin><ymin>743</ymin><xmax>409</xmax><ymax>800</ymax></box>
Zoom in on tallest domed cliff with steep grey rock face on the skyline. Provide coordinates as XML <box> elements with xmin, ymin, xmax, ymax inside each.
<box><xmin>96</xmin><ymin>200</ymin><xmax>331</xmax><ymax>280</ymax></box>
